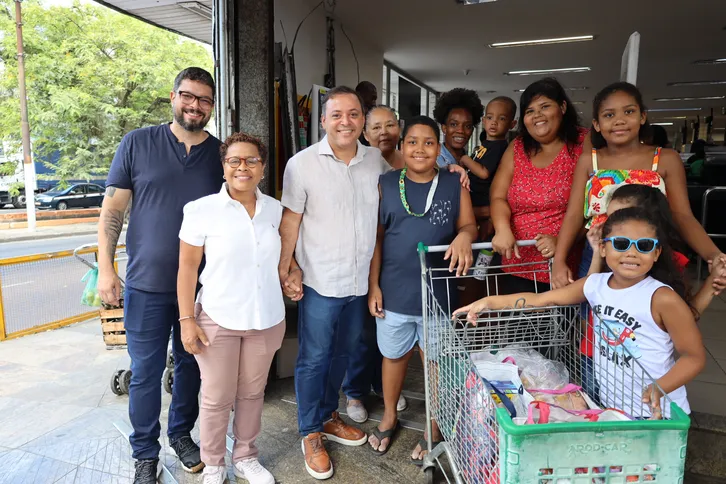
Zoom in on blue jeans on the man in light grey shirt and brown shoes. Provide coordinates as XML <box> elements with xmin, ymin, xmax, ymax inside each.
<box><xmin>295</xmin><ymin>286</ymin><xmax>368</xmax><ymax>436</ymax></box>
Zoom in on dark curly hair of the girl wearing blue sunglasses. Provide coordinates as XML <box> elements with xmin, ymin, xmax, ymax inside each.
<box><xmin>602</xmin><ymin>207</ymin><xmax>698</xmax><ymax>318</ymax></box>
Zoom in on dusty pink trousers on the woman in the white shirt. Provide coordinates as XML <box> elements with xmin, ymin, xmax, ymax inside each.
<box><xmin>196</xmin><ymin>311</ymin><xmax>285</xmax><ymax>466</ymax></box>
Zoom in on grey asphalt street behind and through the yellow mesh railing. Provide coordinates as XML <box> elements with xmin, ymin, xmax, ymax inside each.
<box><xmin>0</xmin><ymin>233</ymin><xmax>126</xmax><ymax>333</ymax></box>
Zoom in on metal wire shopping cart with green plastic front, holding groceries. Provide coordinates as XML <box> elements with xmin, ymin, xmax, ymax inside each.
<box><xmin>419</xmin><ymin>241</ymin><xmax>690</xmax><ymax>484</ymax></box>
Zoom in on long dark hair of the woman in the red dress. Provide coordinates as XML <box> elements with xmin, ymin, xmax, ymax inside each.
<box><xmin>519</xmin><ymin>77</ymin><xmax>580</xmax><ymax>154</ymax></box>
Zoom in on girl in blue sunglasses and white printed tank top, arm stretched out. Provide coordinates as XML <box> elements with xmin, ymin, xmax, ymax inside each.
<box><xmin>454</xmin><ymin>207</ymin><xmax>708</xmax><ymax>418</ymax></box>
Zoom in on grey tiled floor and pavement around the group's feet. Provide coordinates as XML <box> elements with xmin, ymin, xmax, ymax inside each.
<box><xmin>0</xmin><ymin>296</ymin><xmax>726</xmax><ymax>484</ymax></box>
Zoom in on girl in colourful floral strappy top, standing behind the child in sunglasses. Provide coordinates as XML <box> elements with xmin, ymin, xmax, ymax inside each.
<box><xmin>552</xmin><ymin>82</ymin><xmax>726</xmax><ymax>288</ymax></box>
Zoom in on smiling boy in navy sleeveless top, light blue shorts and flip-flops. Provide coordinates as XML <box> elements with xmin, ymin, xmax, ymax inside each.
<box><xmin>368</xmin><ymin>116</ymin><xmax>477</xmax><ymax>466</ymax></box>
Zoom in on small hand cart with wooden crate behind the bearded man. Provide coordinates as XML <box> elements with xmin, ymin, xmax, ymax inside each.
<box><xmin>73</xmin><ymin>244</ymin><xmax>174</xmax><ymax>395</ymax></box>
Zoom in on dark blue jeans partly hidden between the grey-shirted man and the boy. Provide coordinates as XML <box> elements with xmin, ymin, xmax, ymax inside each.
<box><xmin>343</xmin><ymin>316</ymin><xmax>383</xmax><ymax>400</ymax></box>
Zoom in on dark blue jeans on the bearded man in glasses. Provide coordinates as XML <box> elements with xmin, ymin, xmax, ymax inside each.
<box><xmin>124</xmin><ymin>286</ymin><xmax>201</xmax><ymax>459</ymax></box>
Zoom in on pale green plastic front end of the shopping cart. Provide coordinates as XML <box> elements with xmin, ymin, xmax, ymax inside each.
<box><xmin>497</xmin><ymin>403</ymin><xmax>691</xmax><ymax>484</ymax></box>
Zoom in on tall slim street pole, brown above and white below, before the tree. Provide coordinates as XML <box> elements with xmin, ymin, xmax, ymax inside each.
<box><xmin>15</xmin><ymin>0</ymin><xmax>35</xmax><ymax>232</ymax></box>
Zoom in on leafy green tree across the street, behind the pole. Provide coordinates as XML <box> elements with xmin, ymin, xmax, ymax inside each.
<box><xmin>0</xmin><ymin>0</ymin><xmax>213</xmax><ymax>180</ymax></box>
